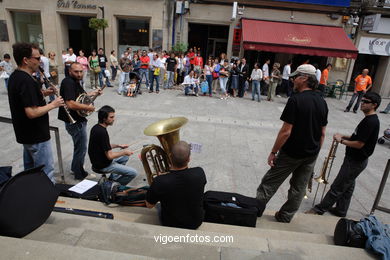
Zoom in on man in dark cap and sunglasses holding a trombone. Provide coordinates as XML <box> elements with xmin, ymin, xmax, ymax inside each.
<box><xmin>306</xmin><ymin>92</ymin><xmax>381</xmax><ymax>217</ymax></box>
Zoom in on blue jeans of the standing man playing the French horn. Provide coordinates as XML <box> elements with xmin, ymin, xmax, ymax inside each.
<box><xmin>65</xmin><ymin>121</ymin><xmax>87</xmax><ymax>179</ymax></box>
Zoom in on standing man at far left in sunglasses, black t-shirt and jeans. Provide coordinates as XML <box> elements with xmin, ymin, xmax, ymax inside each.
<box><xmin>8</xmin><ymin>43</ymin><xmax>64</xmax><ymax>183</ymax></box>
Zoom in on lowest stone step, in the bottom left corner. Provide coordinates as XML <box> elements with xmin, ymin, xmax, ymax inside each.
<box><xmin>0</xmin><ymin>236</ymin><xmax>158</xmax><ymax>260</ymax></box>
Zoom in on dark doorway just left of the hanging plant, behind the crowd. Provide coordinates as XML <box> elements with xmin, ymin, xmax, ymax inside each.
<box><xmin>66</xmin><ymin>15</ymin><xmax>97</xmax><ymax>57</ymax></box>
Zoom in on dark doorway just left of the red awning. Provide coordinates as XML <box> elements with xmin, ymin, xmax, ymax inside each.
<box><xmin>188</xmin><ymin>23</ymin><xmax>229</xmax><ymax>60</ymax></box>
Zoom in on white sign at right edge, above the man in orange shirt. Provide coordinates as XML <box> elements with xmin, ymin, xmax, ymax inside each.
<box><xmin>359</xmin><ymin>37</ymin><xmax>390</xmax><ymax>56</ymax></box>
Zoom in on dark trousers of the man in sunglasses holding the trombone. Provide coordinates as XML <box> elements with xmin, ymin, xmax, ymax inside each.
<box><xmin>314</xmin><ymin>156</ymin><xmax>368</xmax><ymax>216</ymax></box>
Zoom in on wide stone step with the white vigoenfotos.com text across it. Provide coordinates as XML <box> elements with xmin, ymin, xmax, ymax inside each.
<box><xmin>25</xmin><ymin>213</ymin><xmax>372</xmax><ymax>259</ymax></box>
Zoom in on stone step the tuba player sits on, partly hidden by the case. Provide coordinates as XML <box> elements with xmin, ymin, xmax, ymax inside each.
<box><xmin>57</xmin><ymin>197</ymin><xmax>339</xmax><ymax>236</ymax></box>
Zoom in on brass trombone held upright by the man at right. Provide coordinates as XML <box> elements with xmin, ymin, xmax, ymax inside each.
<box><xmin>309</xmin><ymin>139</ymin><xmax>339</xmax><ymax>206</ymax></box>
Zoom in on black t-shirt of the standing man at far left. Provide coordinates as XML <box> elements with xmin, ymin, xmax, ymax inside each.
<box><xmin>8</xmin><ymin>70</ymin><xmax>50</xmax><ymax>144</ymax></box>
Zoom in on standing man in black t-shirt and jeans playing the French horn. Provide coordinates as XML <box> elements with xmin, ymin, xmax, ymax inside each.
<box><xmin>58</xmin><ymin>62</ymin><xmax>101</xmax><ymax>180</ymax></box>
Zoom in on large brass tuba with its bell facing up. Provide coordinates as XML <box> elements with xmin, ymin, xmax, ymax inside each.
<box><xmin>141</xmin><ymin>117</ymin><xmax>188</xmax><ymax>185</ymax></box>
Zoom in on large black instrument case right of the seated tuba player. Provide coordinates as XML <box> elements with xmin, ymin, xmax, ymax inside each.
<box><xmin>204</xmin><ymin>191</ymin><xmax>265</xmax><ymax>227</ymax></box>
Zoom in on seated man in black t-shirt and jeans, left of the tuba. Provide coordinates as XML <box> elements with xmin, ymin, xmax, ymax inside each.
<box><xmin>88</xmin><ymin>106</ymin><xmax>137</xmax><ymax>185</ymax></box>
